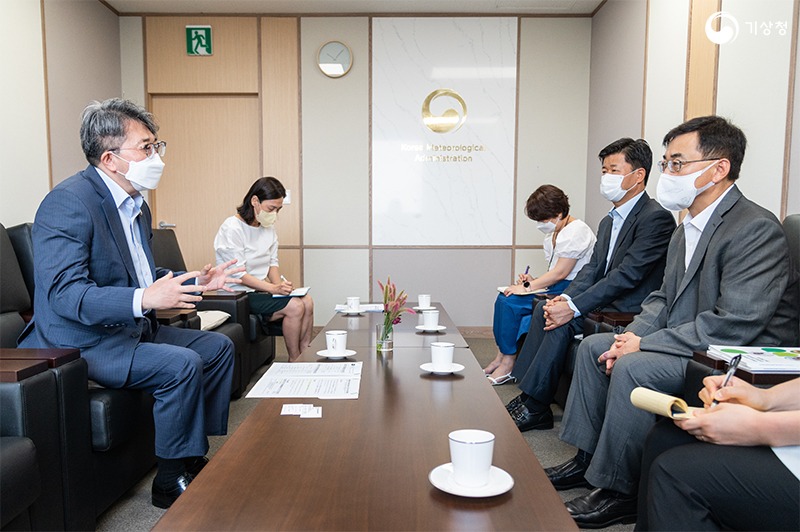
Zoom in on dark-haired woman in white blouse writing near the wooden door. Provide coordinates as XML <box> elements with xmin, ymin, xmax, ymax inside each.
<box><xmin>214</xmin><ymin>177</ymin><xmax>314</xmax><ymax>362</ymax></box>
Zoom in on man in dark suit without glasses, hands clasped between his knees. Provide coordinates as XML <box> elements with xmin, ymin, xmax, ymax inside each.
<box><xmin>506</xmin><ymin>138</ymin><xmax>675</xmax><ymax>431</ymax></box>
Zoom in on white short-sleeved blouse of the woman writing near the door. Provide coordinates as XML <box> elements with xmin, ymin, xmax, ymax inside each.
<box><xmin>214</xmin><ymin>216</ymin><xmax>278</xmax><ymax>292</ymax></box>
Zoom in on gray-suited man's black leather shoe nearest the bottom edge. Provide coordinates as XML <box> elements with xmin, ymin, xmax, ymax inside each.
<box><xmin>567</xmin><ymin>488</ymin><xmax>636</xmax><ymax>528</ymax></box>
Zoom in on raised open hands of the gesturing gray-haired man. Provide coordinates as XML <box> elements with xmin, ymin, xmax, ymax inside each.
<box><xmin>142</xmin><ymin>259</ymin><xmax>245</xmax><ymax>310</ymax></box>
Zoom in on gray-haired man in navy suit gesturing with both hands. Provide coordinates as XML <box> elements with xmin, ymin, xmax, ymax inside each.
<box><xmin>20</xmin><ymin>99</ymin><xmax>238</xmax><ymax>508</ymax></box>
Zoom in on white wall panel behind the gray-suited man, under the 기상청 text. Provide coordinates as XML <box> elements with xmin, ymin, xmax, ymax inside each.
<box><xmin>717</xmin><ymin>0</ymin><xmax>793</xmax><ymax>216</ymax></box>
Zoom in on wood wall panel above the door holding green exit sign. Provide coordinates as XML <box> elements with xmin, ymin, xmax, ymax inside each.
<box><xmin>145</xmin><ymin>17</ymin><xmax>258</xmax><ymax>94</ymax></box>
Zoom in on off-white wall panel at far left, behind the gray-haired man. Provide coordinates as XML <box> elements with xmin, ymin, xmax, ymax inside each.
<box><xmin>0</xmin><ymin>0</ymin><xmax>50</xmax><ymax>227</ymax></box>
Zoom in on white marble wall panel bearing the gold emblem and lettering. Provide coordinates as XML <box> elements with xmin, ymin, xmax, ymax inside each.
<box><xmin>372</xmin><ymin>17</ymin><xmax>517</xmax><ymax>245</ymax></box>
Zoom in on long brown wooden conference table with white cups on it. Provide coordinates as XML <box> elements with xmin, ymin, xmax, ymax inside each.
<box><xmin>155</xmin><ymin>305</ymin><xmax>576</xmax><ymax>530</ymax></box>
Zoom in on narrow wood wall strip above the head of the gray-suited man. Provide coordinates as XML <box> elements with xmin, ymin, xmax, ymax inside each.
<box><xmin>684</xmin><ymin>0</ymin><xmax>721</xmax><ymax>120</ymax></box>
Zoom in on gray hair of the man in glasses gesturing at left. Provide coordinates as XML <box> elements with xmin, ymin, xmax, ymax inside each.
<box><xmin>81</xmin><ymin>98</ymin><xmax>158</xmax><ymax>166</ymax></box>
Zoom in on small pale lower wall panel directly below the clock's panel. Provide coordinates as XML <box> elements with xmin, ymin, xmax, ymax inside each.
<box><xmin>303</xmin><ymin>249</ymin><xmax>370</xmax><ymax>325</ymax></box>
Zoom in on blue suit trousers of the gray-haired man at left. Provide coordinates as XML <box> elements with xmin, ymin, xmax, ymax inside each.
<box><xmin>125</xmin><ymin>327</ymin><xmax>234</xmax><ymax>458</ymax></box>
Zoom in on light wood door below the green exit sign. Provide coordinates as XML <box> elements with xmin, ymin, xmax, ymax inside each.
<box><xmin>151</xmin><ymin>96</ymin><xmax>260</xmax><ymax>269</ymax></box>
